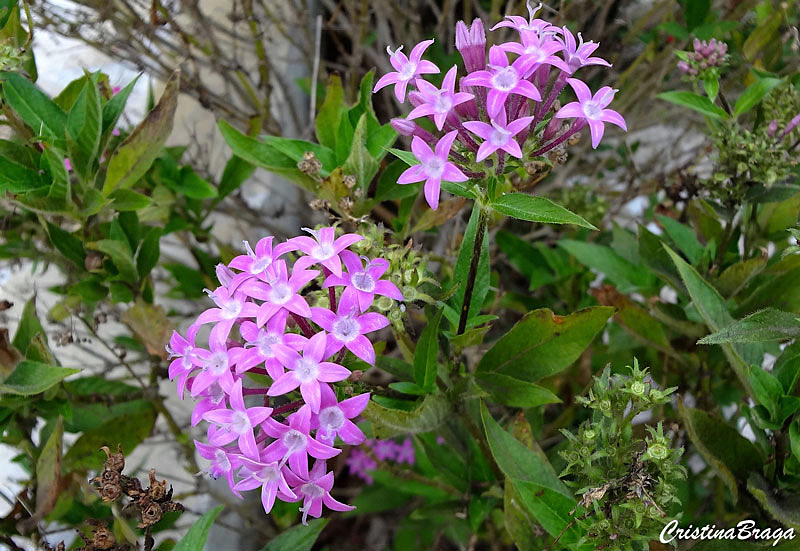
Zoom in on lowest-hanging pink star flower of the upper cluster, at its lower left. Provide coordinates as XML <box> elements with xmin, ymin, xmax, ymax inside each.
<box><xmin>397</xmin><ymin>130</ymin><xmax>466</xmax><ymax>210</ymax></box>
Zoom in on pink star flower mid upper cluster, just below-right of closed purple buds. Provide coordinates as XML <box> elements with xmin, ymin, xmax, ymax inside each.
<box><xmin>463</xmin><ymin>46</ymin><xmax>542</xmax><ymax>118</ymax></box>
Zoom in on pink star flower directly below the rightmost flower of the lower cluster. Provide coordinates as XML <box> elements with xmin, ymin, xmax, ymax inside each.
<box><xmin>311</xmin><ymin>294</ymin><xmax>389</xmax><ymax>365</ymax></box>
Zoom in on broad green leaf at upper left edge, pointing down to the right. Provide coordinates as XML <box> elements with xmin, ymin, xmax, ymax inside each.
<box><xmin>0</xmin><ymin>72</ymin><xmax>67</xmax><ymax>151</ymax></box>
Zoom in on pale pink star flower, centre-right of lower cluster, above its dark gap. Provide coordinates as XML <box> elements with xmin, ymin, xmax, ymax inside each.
<box><xmin>267</xmin><ymin>331</ymin><xmax>350</xmax><ymax>413</ymax></box>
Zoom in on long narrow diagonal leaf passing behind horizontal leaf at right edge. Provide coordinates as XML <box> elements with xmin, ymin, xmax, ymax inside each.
<box><xmin>664</xmin><ymin>245</ymin><xmax>760</xmax><ymax>394</ymax></box>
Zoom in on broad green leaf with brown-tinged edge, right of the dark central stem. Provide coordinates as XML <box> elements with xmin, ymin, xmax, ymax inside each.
<box><xmin>476</xmin><ymin>306</ymin><xmax>614</xmax><ymax>382</ymax></box>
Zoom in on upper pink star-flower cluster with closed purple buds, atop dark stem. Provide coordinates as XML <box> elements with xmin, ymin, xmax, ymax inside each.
<box><xmin>374</xmin><ymin>3</ymin><xmax>626</xmax><ymax>209</ymax></box>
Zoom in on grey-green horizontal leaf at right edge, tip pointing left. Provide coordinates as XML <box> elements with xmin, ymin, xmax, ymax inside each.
<box><xmin>697</xmin><ymin>308</ymin><xmax>800</xmax><ymax>344</ymax></box>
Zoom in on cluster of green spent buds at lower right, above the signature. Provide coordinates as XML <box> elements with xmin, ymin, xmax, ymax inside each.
<box><xmin>559</xmin><ymin>360</ymin><xmax>686</xmax><ymax>551</ymax></box>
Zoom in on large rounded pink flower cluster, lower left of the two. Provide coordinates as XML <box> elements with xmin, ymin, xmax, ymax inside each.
<box><xmin>167</xmin><ymin>227</ymin><xmax>403</xmax><ymax>523</ymax></box>
